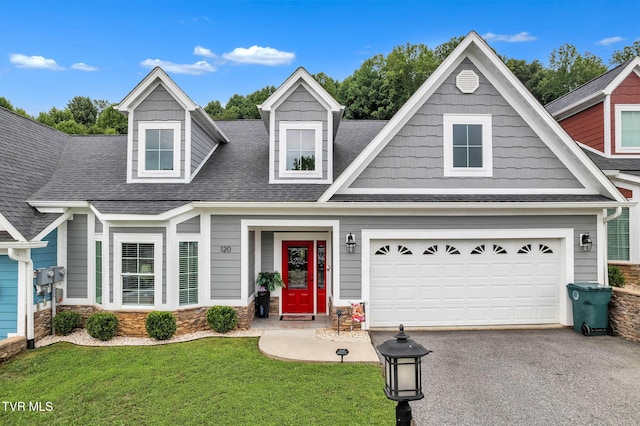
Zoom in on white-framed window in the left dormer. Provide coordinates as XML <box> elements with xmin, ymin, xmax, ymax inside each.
<box><xmin>138</xmin><ymin>121</ymin><xmax>181</xmax><ymax>177</ymax></box>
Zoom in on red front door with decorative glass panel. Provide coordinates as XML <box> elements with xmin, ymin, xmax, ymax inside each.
<box><xmin>282</xmin><ymin>241</ymin><xmax>315</xmax><ymax>314</ymax></box>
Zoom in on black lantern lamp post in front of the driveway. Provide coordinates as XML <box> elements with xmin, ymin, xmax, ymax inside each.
<box><xmin>378</xmin><ymin>324</ymin><xmax>431</xmax><ymax>426</ymax></box>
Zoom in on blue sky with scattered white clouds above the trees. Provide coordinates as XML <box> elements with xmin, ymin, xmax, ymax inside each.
<box><xmin>0</xmin><ymin>0</ymin><xmax>640</xmax><ymax>115</ymax></box>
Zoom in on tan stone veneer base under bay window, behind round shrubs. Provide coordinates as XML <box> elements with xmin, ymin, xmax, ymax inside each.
<box><xmin>59</xmin><ymin>305</ymin><xmax>254</xmax><ymax>337</ymax></box>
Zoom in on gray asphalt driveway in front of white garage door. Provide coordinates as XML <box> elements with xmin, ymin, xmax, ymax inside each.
<box><xmin>371</xmin><ymin>329</ymin><xmax>640</xmax><ymax>425</ymax></box>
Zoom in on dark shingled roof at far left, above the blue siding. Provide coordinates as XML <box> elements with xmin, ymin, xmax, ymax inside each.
<box><xmin>0</xmin><ymin>108</ymin><xmax>69</xmax><ymax>241</ymax></box>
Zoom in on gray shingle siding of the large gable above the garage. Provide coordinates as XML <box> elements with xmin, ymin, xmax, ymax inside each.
<box><xmin>351</xmin><ymin>59</ymin><xmax>582</xmax><ymax>188</ymax></box>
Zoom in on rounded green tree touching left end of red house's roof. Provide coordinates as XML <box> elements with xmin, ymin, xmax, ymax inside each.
<box><xmin>535</xmin><ymin>44</ymin><xmax>607</xmax><ymax>104</ymax></box>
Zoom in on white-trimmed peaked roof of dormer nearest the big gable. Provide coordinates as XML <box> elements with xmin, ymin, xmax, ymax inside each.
<box><xmin>258</xmin><ymin>67</ymin><xmax>344</xmax><ymax>136</ymax></box>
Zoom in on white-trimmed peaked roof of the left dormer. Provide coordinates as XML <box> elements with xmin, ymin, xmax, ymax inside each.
<box><xmin>115</xmin><ymin>67</ymin><xmax>228</xmax><ymax>143</ymax></box>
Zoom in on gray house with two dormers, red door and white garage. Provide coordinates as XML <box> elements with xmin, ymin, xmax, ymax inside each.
<box><xmin>0</xmin><ymin>32</ymin><xmax>628</xmax><ymax>346</ymax></box>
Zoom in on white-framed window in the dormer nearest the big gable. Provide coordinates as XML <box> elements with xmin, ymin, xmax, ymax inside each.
<box><xmin>279</xmin><ymin>121</ymin><xmax>322</xmax><ymax>178</ymax></box>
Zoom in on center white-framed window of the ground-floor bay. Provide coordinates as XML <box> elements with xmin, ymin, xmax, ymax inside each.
<box><xmin>113</xmin><ymin>234</ymin><xmax>162</xmax><ymax>308</ymax></box>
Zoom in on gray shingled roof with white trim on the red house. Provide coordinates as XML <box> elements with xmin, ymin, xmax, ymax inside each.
<box><xmin>545</xmin><ymin>57</ymin><xmax>640</xmax><ymax>117</ymax></box>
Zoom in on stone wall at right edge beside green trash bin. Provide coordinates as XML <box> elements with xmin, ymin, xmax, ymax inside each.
<box><xmin>609</xmin><ymin>287</ymin><xmax>640</xmax><ymax>342</ymax></box>
